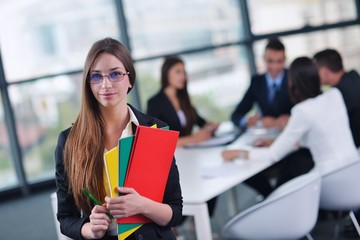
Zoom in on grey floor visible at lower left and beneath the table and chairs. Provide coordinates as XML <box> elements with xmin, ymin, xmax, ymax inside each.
<box><xmin>0</xmin><ymin>185</ymin><xmax>360</xmax><ymax>240</ymax></box>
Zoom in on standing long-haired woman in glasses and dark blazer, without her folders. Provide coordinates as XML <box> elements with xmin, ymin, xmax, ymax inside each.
<box><xmin>55</xmin><ymin>38</ymin><xmax>182</xmax><ymax>239</ymax></box>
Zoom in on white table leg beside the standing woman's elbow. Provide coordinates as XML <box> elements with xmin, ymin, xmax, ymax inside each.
<box><xmin>183</xmin><ymin>203</ymin><xmax>212</xmax><ymax>240</ymax></box>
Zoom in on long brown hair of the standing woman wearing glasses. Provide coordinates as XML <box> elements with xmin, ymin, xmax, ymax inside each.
<box><xmin>64</xmin><ymin>38</ymin><xmax>135</xmax><ymax>214</ymax></box>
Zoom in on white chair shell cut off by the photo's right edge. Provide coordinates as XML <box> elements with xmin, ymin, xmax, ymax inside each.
<box><xmin>320</xmin><ymin>160</ymin><xmax>360</xmax><ymax>210</ymax></box>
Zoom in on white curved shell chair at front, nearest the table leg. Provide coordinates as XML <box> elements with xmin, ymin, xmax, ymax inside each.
<box><xmin>222</xmin><ymin>172</ymin><xmax>321</xmax><ymax>240</ymax></box>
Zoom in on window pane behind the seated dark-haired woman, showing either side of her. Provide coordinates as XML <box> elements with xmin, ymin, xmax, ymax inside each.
<box><xmin>136</xmin><ymin>47</ymin><xmax>250</xmax><ymax>121</ymax></box>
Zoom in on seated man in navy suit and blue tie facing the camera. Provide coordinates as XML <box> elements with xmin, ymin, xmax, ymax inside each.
<box><xmin>231</xmin><ymin>39</ymin><xmax>293</xmax><ymax>129</ymax></box>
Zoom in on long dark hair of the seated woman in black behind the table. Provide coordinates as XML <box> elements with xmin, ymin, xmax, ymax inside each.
<box><xmin>161</xmin><ymin>56</ymin><xmax>197</xmax><ymax>135</ymax></box>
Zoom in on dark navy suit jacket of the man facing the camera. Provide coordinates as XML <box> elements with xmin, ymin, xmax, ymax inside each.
<box><xmin>231</xmin><ymin>70</ymin><xmax>293</xmax><ymax>126</ymax></box>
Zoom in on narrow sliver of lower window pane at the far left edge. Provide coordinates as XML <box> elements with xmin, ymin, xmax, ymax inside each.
<box><xmin>0</xmin><ymin>93</ymin><xmax>18</xmax><ymax>190</ymax></box>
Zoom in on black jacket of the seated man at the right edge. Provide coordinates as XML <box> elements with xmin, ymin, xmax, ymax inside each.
<box><xmin>335</xmin><ymin>70</ymin><xmax>360</xmax><ymax>147</ymax></box>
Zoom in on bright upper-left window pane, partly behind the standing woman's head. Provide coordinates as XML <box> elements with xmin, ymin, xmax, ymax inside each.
<box><xmin>0</xmin><ymin>0</ymin><xmax>119</xmax><ymax>82</ymax></box>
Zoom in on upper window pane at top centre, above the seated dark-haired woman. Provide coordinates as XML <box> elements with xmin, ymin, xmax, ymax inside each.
<box><xmin>124</xmin><ymin>0</ymin><xmax>243</xmax><ymax>58</ymax></box>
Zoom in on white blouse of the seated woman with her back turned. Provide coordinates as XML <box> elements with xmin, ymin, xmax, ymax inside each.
<box><xmin>250</xmin><ymin>88</ymin><xmax>359</xmax><ymax>174</ymax></box>
